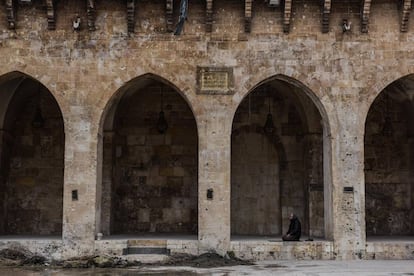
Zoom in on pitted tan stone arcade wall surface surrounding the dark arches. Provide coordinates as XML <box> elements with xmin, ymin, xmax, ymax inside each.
<box><xmin>0</xmin><ymin>1</ymin><xmax>414</xmax><ymax>259</ymax></box>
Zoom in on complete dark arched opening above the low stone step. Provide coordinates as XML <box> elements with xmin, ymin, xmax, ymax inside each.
<box><xmin>100</xmin><ymin>74</ymin><xmax>198</xmax><ymax>235</ymax></box>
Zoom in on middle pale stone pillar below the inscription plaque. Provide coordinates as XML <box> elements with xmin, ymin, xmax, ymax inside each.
<box><xmin>197</xmin><ymin>101</ymin><xmax>231</xmax><ymax>254</ymax></box>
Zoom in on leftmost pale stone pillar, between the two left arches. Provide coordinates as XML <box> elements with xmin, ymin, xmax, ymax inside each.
<box><xmin>62</xmin><ymin>105</ymin><xmax>100</xmax><ymax>258</ymax></box>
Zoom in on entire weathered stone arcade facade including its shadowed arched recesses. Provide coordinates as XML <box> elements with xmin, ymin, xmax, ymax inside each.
<box><xmin>0</xmin><ymin>0</ymin><xmax>414</xmax><ymax>259</ymax></box>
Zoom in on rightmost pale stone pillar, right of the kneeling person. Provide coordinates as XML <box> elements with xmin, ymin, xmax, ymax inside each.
<box><xmin>332</xmin><ymin>100</ymin><xmax>366</xmax><ymax>259</ymax></box>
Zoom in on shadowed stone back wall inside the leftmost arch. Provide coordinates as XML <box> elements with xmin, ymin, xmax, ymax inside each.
<box><xmin>2</xmin><ymin>82</ymin><xmax>64</xmax><ymax>235</ymax></box>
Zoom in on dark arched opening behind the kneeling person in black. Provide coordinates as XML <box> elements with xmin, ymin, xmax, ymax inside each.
<box><xmin>231</xmin><ymin>78</ymin><xmax>325</xmax><ymax>239</ymax></box>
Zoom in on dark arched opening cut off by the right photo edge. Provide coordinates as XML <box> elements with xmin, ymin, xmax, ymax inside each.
<box><xmin>364</xmin><ymin>75</ymin><xmax>414</xmax><ymax>238</ymax></box>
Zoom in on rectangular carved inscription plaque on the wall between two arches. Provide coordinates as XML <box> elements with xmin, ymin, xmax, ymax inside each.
<box><xmin>197</xmin><ymin>67</ymin><xmax>233</xmax><ymax>95</ymax></box>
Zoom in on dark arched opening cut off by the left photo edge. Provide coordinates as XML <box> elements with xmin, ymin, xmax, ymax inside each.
<box><xmin>0</xmin><ymin>72</ymin><xmax>65</xmax><ymax>235</ymax></box>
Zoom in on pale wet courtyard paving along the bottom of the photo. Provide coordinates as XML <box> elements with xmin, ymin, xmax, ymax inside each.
<box><xmin>0</xmin><ymin>260</ymin><xmax>414</xmax><ymax>276</ymax></box>
